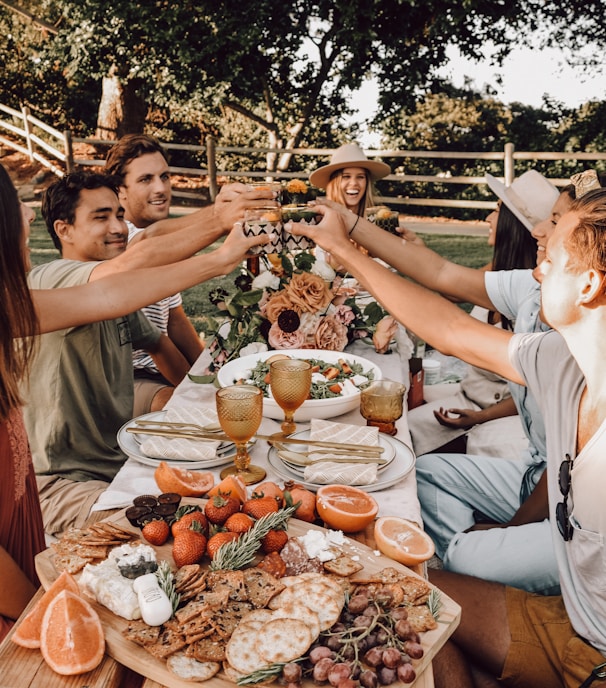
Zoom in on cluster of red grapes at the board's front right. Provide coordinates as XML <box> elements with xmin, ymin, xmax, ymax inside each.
<box><xmin>282</xmin><ymin>588</ymin><xmax>423</xmax><ymax>688</ymax></box>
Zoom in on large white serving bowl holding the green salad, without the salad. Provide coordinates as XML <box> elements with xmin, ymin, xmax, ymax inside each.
<box><xmin>217</xmin><ymin>349</ymin><xmax>383</xmax><ymax>423</ymax></box>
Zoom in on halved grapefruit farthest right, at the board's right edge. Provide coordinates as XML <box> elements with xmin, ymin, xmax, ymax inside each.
<box><xmin>374</xmin><ymin>516</ymin><xmax>435</xmax><ymax>566</ymax></box>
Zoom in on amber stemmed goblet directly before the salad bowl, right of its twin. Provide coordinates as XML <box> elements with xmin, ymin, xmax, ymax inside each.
<box><xmin>269</xmin><ymin>358</ymin><xmax>311</xmax><ymax>435</ymax></box>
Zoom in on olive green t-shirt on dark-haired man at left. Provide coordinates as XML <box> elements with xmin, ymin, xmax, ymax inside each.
<box><xmin>23</xmin><ymin>259</ymin><xmax>160</xmax><ymax>481</ymax></box>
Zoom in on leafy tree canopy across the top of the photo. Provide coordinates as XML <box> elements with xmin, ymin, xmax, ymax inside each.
<box><xmin>0</xmin><ymin>0</ymin><xmax>606</xmax><ymax>169</ymax></box>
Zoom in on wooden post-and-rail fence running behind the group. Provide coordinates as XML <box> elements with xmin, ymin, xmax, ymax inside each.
<box><xmin>0</xmin><ymin>104</ymin><xmax>606</xmax><ymax>209</ymax></box>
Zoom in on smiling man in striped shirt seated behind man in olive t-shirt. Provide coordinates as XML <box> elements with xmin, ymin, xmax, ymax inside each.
<box><xmin>106</xmin><ymin>134</ymin><xmax>204</xmax><ymax>416</ymax></box>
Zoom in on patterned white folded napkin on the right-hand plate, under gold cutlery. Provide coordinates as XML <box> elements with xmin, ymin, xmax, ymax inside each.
<box><xmin>303</xmin><ymin>418</ymin><xmax>379</xmax><ymax>485</ymax></box>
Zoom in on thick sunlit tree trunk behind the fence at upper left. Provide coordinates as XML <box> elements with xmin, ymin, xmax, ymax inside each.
<box><xmin>95</xmin><ymin>67</ymin><xmax>146</xmax><ymax>141</ymax></box>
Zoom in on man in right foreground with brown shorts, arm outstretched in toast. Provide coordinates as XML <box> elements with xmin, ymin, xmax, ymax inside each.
<box><xmin>291</xmin><ymin>190</ymin><xmax>606</xmax><ymax>688</ymax></box>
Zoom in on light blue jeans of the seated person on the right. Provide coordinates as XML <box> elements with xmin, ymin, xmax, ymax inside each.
<box><xmin>416</xmin><ymin>454</ymin><xmax>559</xmax><ymax>595</ymax></box>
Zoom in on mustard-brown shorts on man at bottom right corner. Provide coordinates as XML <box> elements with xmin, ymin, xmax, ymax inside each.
<box><xmin>501</xmin><ymin>588</ymin><xmax>606</xmax><ymax>688</ymax></box>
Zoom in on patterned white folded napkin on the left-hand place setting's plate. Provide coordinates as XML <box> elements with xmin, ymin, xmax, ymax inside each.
<box><xmin>141</xmin><ymin>407</ymin><xmax>221</xmax><ymax>461</ymax></box>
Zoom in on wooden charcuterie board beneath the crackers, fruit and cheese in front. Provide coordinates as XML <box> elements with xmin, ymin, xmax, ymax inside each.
<box><xmin>36</xmin><ymin>499</ymin><xmax>461</xmax><ymax>688</ymax></box>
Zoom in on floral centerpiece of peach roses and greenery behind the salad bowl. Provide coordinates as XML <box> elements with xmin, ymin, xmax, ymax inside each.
<box><xmin>204</xmin><ymin>251</ymin><xmax>397</xmax><ymax>373</ymax></box>
